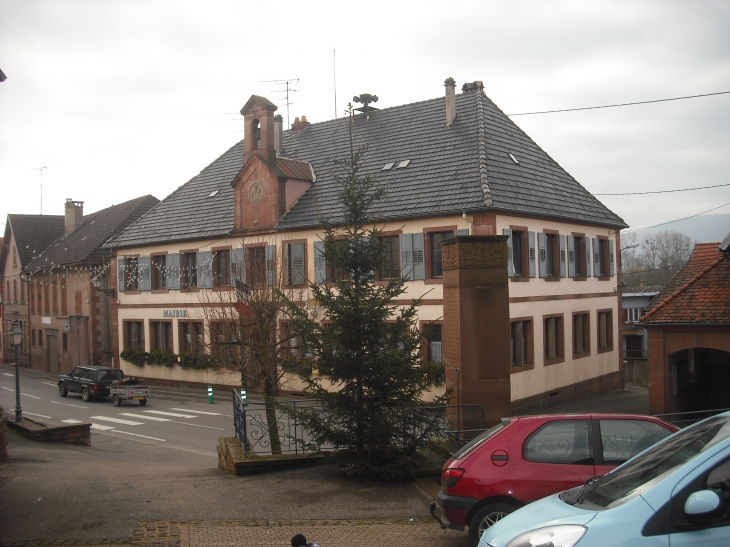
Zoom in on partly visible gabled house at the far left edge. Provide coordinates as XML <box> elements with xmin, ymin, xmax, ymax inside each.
<box><xmin>0</xmin><ymin>215</ymin><xmax>63</xmax><ymax>367</ymax></box>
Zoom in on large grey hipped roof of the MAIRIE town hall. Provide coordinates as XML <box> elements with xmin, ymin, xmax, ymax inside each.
<box><xmin>105</xmin><ymin>92</ymin><xmax>627</xmax><ymax>247</ymax></box>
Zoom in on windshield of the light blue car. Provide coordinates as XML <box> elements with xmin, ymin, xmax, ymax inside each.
<box><xmin>565</xmin><ymin>416</ymin><xmax>730</xmax><ymax>510</ymax></box>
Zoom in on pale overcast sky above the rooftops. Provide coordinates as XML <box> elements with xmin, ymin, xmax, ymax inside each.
<box><xmin>0</xmin><ymin>0</ymin><xmax>730</xmax><ymax>233</ymax></box>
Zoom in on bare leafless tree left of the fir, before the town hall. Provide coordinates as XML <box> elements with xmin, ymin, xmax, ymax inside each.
<box><xmin>195</xmin><ymin>237</ymin><xmax>308</xmax><ymax>454</ymax></box>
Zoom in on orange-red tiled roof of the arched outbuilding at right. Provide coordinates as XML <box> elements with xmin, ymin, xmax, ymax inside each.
<box><xmin>641</xmin><ymin>243</ymin><xmax>730</xmax><ymax>325</ymax></box>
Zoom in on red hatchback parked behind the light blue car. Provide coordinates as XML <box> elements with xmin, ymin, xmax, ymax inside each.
<box><xmin>431</xmin><ymin>414</ymin><xmax>677</xmax><ymax>546</ymax></box>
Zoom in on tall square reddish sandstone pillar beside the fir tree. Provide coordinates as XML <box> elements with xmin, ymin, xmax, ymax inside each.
<box><xmin>442</xmin><ymin>235</ymin><xmax>511</xmax><ymax>428</ymax></box>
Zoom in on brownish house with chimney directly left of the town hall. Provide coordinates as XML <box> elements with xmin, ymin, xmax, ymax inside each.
<box><xmin>23</xmin><ymin>195</ymin><xmax>159</xmax><ymax>373</ymax></box>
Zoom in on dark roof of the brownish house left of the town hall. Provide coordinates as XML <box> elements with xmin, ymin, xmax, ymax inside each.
<box><xmin>24</xmin><ymin>195</ymin><xmax>160</xmax><ymax>270</ymax></box>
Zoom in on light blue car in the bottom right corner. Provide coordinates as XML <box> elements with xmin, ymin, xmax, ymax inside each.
<box><xmin>479</xmin><ymin>412</ymin><xmax>730</xmax><ymax>547</ymax></box>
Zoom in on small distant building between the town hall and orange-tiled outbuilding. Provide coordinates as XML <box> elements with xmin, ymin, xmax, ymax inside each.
<box><xmin>621</xmin><ymin>283</ymin><xmax>661</xmax><ymax>386</ymax></box>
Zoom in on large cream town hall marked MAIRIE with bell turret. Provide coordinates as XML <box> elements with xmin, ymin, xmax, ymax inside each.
<box><xmin>102</xmin><ymin>79</ymin><xmax>626</xmax><ymax>408</ymax></box>
